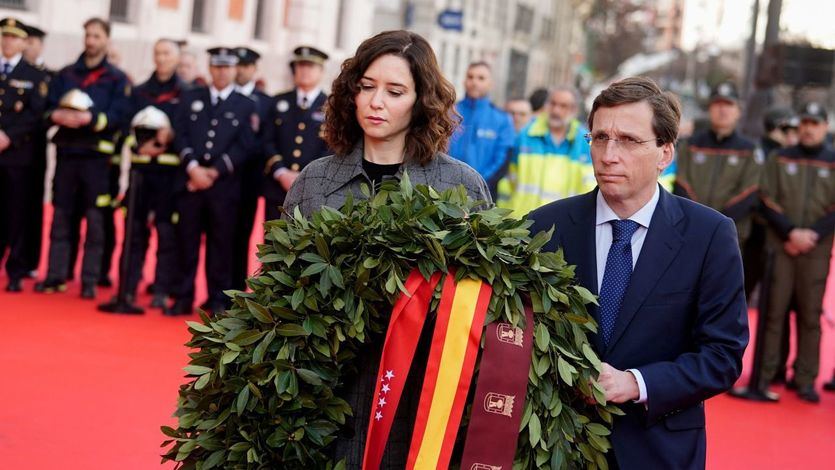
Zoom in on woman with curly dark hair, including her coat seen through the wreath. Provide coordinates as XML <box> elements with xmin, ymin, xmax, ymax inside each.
<box><xmin>284</xmin><ymin>31</ymin><xmax>492</xmax><ymax>469</ymax></box>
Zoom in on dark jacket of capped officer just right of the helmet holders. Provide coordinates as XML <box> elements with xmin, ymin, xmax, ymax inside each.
<box><xmin>174</xmin><ymin>87</ymin><xmax>255</xmax><ymax>178</ymax></box>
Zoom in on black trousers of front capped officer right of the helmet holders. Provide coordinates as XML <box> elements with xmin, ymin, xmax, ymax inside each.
<box><xmin>175</xmin><ymin>175</ymin><xmax>241</xmax><ymax>305</ymax></box>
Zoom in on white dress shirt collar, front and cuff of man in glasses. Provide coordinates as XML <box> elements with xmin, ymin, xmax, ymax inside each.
<box><xmin>594</xmin><ymin>185</ymin><xmax>661</xmax><ymax>403</ymax></box>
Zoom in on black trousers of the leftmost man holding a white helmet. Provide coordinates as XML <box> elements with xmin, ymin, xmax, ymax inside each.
<box><xmin>46</xmin><ymin>156</ymin><xmax>110</xmax><ymax>284</ymax></box>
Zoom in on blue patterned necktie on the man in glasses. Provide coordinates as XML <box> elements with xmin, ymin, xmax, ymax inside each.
<box><xmin>600</xmin><ymin>220</ymin><xmax>638</xmax><ymax>345</ymax></box>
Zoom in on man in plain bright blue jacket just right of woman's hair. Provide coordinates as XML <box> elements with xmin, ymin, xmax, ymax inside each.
<box><xmin>449</xmin><ymin>62</ymin><xmax>515</xmax><ymax>198</ymax></box>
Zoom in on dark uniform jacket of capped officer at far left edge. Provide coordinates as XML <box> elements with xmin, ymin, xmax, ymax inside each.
<box><xmin>0</xmin><ymin>59</ymin><xmax>48</xmax><ymax>166</ymax></box>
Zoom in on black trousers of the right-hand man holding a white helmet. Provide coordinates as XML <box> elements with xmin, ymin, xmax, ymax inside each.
<box><xmin>122</xmin><ymin>167</ymin><xmax>180</xmax><ymax>294</ymax></box>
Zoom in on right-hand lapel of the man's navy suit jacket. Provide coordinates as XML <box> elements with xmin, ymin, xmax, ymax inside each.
<box><xmin>606</xmin><ymin>187</ymin><xmax>684</xmax><ymax>354</ymax></box>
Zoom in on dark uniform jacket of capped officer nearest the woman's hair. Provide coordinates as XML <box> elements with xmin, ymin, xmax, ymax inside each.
<box><xmin>264</xmin><ymin>90</ymin><xmax>330</xmax><ymax>202</ymax></box>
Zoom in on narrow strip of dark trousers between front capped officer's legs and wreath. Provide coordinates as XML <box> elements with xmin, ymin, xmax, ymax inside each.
<box><xmin>232</xmin><ymin>159</ymin><xmax>263</xmax><ymax>290</ymax></box>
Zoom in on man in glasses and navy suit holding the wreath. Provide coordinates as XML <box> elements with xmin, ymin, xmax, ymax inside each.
<box><xmin>529</xmin><ymin>78</ymin><xmax>748</xmax><ymax>469</ymax></box>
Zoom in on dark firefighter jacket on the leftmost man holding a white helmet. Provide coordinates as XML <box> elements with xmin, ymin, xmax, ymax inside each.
<box><xmin>47</xmin><ymin>54</ymin><xmax>131</xmax><ymax>155</ymax></box>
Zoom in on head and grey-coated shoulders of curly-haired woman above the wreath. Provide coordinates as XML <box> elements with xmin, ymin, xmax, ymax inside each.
<box><xmin>284</xmin><ymin>27</ymin><xmax>492</xmax><ymax>215</ymax></box>
